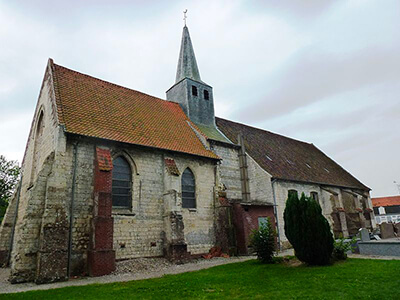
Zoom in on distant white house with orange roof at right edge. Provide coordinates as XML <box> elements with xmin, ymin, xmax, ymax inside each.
<box><xmin>371</xmin><ymin>196</ymin><xmax>400</xmax><ymax>224</ymax></box>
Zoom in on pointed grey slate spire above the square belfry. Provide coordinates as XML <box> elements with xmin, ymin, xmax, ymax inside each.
<box><xmin>175</xmin><ymin>25</ymin><xmax>202</xmax><ymax>83</ymax></box>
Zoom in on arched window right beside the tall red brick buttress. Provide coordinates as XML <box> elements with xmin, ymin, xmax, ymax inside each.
<box><xmin>112</xmin><ymin>156</ymin><xmax>132</xmax><ymax>208</ymax></box>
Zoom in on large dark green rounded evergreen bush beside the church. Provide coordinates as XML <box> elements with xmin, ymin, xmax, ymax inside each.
<box><xmin>284</xmin><ymin>193</ymin><xmax>334</xmax><ymax>265</ymax></box>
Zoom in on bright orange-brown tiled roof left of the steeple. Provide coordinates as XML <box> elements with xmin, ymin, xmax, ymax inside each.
<box><xmin>49</xmin><ymin>60</ymin><xmax>218</xmax><ymax>159</ymax></box>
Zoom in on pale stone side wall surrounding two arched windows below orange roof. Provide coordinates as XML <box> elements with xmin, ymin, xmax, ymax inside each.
<box><xmin>111</xmin><ymin>146</ymin><xmax>215</xmax><ymax>259</ymax></box>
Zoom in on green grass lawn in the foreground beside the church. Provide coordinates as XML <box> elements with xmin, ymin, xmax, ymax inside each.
<box><xmin>0</xmin><ymin>259</ymin><xmax>400</xmax><ymax>300</ymax></box>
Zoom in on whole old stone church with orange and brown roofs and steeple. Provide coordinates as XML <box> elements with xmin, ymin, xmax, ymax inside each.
<box><xmin>0</xmin><ymin>26</ymin><xmax>375</xmax><ymax>283</ymax></box>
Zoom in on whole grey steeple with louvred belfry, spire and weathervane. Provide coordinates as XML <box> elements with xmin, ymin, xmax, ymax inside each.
<box><xmin>167</xmin><ymin>22</ymin><xmax>215</xmax><ymax>127</ymax></box>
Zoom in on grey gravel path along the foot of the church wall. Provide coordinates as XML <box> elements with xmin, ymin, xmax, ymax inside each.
<box><xmin>0</xmin><ymin>256</ymin><xmax>255</xmax><ymax>294</ymax></box>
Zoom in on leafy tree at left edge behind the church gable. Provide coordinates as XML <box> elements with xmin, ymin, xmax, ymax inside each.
<box><xmin>0</xmin><ymin>155</ymin><xmax>21</xmax><ymax>222</ymax></box>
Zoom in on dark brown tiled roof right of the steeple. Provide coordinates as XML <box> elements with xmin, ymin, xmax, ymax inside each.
<box><xmin>215</xmin><ymin>118</ymin><xmax>369</xmax><ymax>190</ymax></box>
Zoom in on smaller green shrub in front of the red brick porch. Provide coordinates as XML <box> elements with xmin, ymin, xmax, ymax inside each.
<box><xmin>250</xmin><ymin>218</ymin><xmax>275</xmax><ymax>263</ymax></box>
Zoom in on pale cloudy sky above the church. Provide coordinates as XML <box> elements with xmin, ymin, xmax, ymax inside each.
<box><xmin>0</xmin><ymin>0</ymin><xmax>400</xmax><ymax>197</ymax></box>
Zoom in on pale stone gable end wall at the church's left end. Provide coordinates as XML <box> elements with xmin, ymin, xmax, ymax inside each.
<box><xmin>4</xmin><ymin>62</ymin><xmax>72</xmax><ymax>282</ymax></box>
